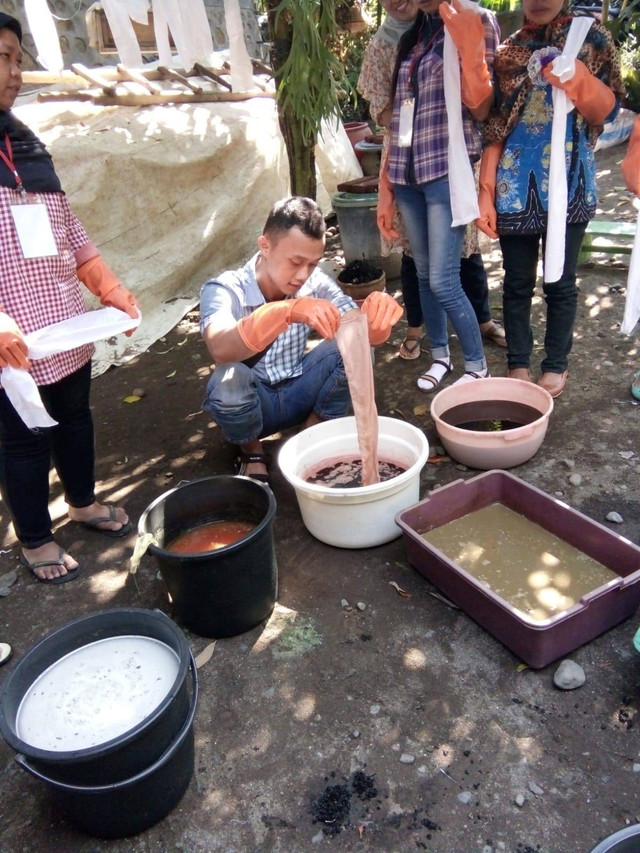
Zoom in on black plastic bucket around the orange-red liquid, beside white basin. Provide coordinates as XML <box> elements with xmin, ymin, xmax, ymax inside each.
<box><xmin>138</xmin><ymin>476</ymin><xmax>278</xmax><ymax>637</ymax></box>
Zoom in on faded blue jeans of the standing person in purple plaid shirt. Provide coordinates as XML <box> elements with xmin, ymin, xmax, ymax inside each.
<box><xmin>393</xmin><ymin>177</ymin><xmax>487</xmax><ymax>371</ymax></box>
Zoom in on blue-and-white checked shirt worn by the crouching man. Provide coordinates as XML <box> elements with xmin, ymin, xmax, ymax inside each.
<box><xmin>200</xmin><ymin>253</ymin><xmax>356</xmax><ymax>385</ymax></box>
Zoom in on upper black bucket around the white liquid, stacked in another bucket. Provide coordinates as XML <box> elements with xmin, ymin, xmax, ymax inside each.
<box><xmin>0</xmin><ymin>608</ymin><xmax>190</xmax><ymax>785</ymax></box>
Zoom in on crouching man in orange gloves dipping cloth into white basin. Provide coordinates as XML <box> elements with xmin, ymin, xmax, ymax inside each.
<box><xmin>200</xmin><ymin>196</ymin><xmax>402</xmax><ymax>481</ymax></box>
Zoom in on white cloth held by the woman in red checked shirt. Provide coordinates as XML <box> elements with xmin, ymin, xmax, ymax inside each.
<box><xmin>1</xmin><ymin>308</ymin><xmax>142</xmax><ymax>429</ymax></box>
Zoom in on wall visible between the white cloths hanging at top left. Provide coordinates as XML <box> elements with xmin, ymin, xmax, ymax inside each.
<box><xmin>0</xmin><ymin>0</ymin><xmax>265</xmax><ymax>69</ymax></box>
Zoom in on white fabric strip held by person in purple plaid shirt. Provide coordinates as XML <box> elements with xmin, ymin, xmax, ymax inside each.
<box><xmin>442</xmin><ymin>0</ymin><xmax>480</xmax><ymax>228</ymax></box>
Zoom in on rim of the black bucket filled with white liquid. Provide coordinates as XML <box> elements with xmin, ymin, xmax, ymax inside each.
<box><xmin>0</xmin><ymin>607</ymin><xmax>191</xmax><ymax>764</ymax></box>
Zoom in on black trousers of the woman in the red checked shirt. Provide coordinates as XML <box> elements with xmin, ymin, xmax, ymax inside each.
<box><xmin>0</xmin><ymin>362</ymin><xmax>95</xmax><ymax>548</ymax></box>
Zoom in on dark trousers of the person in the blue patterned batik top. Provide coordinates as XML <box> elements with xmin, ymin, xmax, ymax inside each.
<box><xmin>500</xmin><ymin>223</ymin><xmax>587</xmax><ymax>373</ymax></box>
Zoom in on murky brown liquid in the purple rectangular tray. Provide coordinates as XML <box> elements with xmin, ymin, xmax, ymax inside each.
<box><xmin>423</xmin><ymin>503</ymin><xmax>619</xmax><ymax>622</ymax></box>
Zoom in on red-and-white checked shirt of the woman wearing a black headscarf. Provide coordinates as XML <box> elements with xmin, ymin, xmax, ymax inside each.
<box><xmin>0</xmin><ymin>186</ymin><xmax>94</xmax><ymax>385</ymax></box>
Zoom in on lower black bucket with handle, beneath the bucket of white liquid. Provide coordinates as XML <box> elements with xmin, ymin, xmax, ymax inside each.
<box><xmin>16</xmin><ymin>655</ymin><xmax>198</xmax><ymax>838</ymax></box>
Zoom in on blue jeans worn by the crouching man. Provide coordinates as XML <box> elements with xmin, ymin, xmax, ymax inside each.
<box><xmin>202</xmin><ymin>341</ymin><xmax>350</xmax><ymax>444</ymax></box>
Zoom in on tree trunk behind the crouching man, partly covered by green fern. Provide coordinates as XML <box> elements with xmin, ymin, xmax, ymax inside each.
<box><xmin>268</xmin><ymin>0</ymin><xmax>317</xmax><ymax>200</ymax></box>
